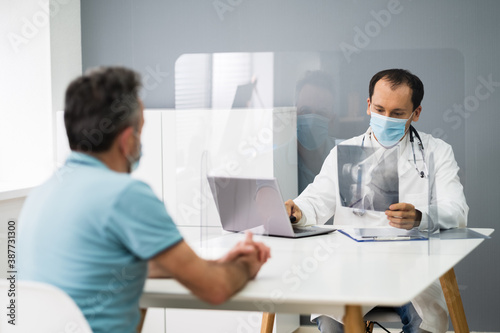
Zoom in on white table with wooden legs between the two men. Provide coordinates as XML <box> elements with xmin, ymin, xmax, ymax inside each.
<box><xmin>140</xmin><ymin>229</ymin><xmax>493</xmax><ymax>332</ymax></box>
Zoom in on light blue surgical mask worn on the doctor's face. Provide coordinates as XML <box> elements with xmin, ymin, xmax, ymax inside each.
<box><xmin>370</xmin><ymin>112</ymin><xmax>413</xmax><ymax>148</ymax></box>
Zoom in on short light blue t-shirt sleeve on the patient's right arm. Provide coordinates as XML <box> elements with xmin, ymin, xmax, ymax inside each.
<box><xmin>107</xmin><ymin>180</ymin><xmax>182</xmax><ymax>260</ymax></box>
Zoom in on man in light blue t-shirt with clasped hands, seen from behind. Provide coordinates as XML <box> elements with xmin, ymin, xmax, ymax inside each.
<box><xmin>18</xmin><ymin>67</ymin><xmax>270</xmax><ymax>333</ymax></box>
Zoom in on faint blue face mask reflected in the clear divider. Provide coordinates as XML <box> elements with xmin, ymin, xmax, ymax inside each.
<box><xmin>297</xmin><ymin>113</ymin><xmax>329</xmax><ymax>150</ymax></box>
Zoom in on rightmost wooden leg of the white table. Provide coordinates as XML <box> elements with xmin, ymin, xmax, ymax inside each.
<box><xmin>439</xmin><ymin>268</ymin><xmax>469</xmax><ymax>333</ymax></box>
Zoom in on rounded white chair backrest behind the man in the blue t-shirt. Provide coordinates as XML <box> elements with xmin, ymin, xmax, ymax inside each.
<box><xmin>0</xmin><ymin>279</ymin><xmax>92</xmax><ymax>333</ymax></box>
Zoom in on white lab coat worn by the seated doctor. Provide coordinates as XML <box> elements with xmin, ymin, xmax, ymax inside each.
<box><xmin>294</xmin><ymin>128</ymin><xmax>469</xmax><ymax>332</ymax></box>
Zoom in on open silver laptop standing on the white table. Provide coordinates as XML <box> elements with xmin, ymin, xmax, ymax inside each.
<box><xmin>207</xmin><ymin>176</ymin><xmax>335</xmax><ymax>238</ymax></box>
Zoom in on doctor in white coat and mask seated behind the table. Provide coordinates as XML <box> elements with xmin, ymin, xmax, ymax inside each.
<box><xmin>285</xmin><ymin>69</ymin><xmax>469</xmax><ymax>332</ymax></box>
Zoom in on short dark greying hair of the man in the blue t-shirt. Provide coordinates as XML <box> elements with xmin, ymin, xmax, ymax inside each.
<box><xmin>64</xmin><ymin>67</ymin><xmax>141</xmax><ymax>153</ymax></box>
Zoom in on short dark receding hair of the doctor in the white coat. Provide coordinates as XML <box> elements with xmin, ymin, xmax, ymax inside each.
<box><xmin>368</xmin><ymin>68</ymin><xmax>424</xmax><ymax>110</ymax></box>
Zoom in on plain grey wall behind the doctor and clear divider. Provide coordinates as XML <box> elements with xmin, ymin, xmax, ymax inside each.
<box><xmin>82</xmin><ymin>0</ymin><xmax>500</xmax><ymax>332</ymax></box>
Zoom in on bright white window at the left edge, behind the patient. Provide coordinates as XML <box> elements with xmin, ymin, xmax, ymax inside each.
<box><xmin>0</xmin><ymin>1</ymin><xmax>53</xmax><ymax>192</ymax></box>
